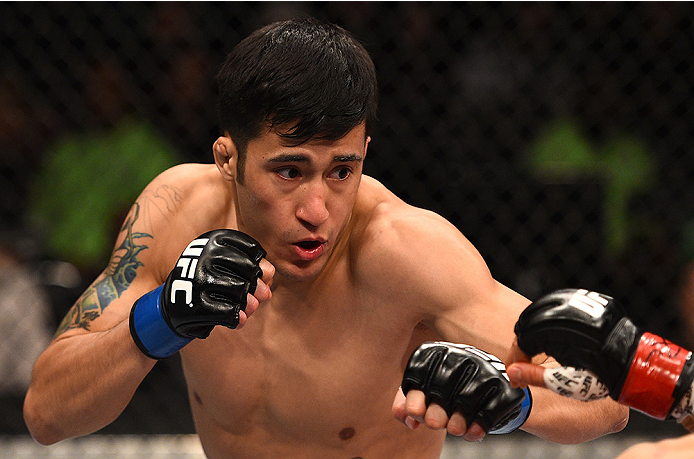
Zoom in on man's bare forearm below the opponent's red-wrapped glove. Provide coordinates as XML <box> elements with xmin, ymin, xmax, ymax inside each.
<box><xmin>521</xmin><ymin>387</ymin><xmax>629</xmax><ymax>444</ymax></box>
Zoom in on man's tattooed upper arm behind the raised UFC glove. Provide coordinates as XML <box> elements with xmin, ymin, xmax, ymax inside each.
<box><xmin>55</xmin><ymin>170</ymin><xmax>189</xmax><ymax>339</ymax></box>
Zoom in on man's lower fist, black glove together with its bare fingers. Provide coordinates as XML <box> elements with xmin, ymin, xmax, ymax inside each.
<box><xmin>393</xmin><ymin>342</ymin><xmax>532</xmax><ymax>441</ymax></box>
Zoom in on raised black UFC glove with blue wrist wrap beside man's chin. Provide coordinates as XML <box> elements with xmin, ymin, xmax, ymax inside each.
<box><xmin>130</xmin><ymin>229</ymin><xmax>269</xmax><ymax>359</ymax></box>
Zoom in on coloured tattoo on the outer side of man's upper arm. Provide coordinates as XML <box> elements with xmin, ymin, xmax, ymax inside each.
<box><xmin>55</xmin><ymin>202</ymin><xmax>152</xmax><ymax>337</ymax></box>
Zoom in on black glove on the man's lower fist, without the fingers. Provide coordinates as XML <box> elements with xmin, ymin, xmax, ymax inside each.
<box><xmin>402</xmin><ymin>342</ymin><xmax>532</xmax><ymax>434</ymax></box>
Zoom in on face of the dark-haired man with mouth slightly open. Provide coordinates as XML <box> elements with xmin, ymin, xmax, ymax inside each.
<box><xmin>236</xmin><ymin>124</ymin><xmax>370</xmax><ymax>280</ymax></box>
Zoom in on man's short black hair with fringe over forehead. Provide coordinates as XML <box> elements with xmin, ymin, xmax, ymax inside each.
<box><xmin>217</xmin><ymin>18</ymin><xmax>378</xmax><ymax>181</ymax></box>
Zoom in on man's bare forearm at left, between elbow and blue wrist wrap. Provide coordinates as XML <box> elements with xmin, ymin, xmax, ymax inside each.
<box><xmin>24</xmin><ymin>320</ymin><xmax>156</xmax><ymax>444</ymax></box>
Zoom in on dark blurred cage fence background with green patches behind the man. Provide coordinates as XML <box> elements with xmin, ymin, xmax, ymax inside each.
<box><xmin>0</xmin><ymin>1</ymin><xmax>694</xmax><ymax>457</ymax></box>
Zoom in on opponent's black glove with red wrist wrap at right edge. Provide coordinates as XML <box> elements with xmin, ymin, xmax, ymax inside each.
<box><xmin>515</xmin><ymin>289</ymin><xmax>694</xmax><ymax>420</ymax></box>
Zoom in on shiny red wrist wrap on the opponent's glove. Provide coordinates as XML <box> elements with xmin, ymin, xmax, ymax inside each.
<box><xmin>619</xmin><ymin>333</ymin><xmax>690</xmax><ymax>419</ymax></box>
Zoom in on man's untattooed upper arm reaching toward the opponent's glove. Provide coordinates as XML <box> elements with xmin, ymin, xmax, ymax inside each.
<box><xmin>370</xmin><ymin>209</ymin><xmax>529</xmax><ymax>358</ymax></box>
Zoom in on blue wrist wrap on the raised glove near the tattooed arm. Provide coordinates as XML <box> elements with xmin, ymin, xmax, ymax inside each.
<box><xmin>130</xmin><ymin>285</ymin><xmax>192</xmax><ymax>359</ymax></box>
